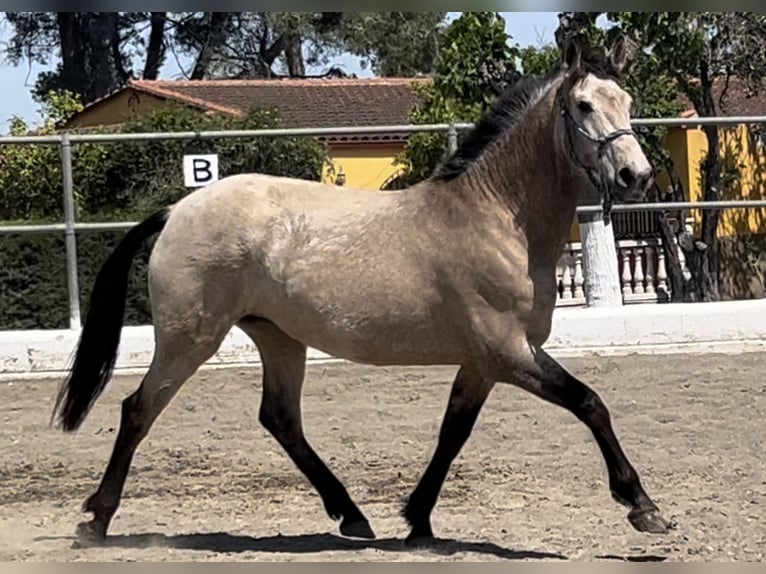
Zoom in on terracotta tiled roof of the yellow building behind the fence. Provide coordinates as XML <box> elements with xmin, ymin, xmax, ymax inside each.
<box><xmin>75</xmin><ymin>78</ymin><xmax>430</xmax><ymax>145</ymax></box>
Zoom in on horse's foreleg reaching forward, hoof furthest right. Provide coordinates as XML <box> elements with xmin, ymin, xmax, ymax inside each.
<box><xmin>505</xmin><ymin>349</ymin><xmax>672</xmax><ymax>534</ymax></box>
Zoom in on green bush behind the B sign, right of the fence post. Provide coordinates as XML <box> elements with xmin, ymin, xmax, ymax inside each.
<box><xmin>75</xmin><ymin>104</ymin><xmax>327</xmax><ymax>220</ymax></box>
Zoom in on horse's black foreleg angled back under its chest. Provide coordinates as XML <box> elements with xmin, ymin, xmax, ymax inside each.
<box><xmin>402</xmin><ymin>367</ymin><xmax>494</xmax><ymax>543</ymax></box>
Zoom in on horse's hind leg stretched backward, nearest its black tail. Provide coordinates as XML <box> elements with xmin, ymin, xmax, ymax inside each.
<box><xmin>77</xmin><ymin>326</ymin><xmax>225</xmax><ymax>544</ymax></box>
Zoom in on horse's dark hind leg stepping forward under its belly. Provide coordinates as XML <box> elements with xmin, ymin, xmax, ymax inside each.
<box><xmin>237</xmin><ymin>318</ymin><xmax>375</xmax><ymax>538</ymax></box>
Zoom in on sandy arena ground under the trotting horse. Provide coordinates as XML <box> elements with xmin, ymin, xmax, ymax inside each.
<box><xmin>0</xmin><ymin>354</ymin><xmax>766</xmax><ymax>561</ymax></box>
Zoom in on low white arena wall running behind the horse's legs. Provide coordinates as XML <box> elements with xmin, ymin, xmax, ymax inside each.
<box><xmin>0</xmin><ymin>299</ymin><xmax>766</xmax><ymax>380</ymax></box>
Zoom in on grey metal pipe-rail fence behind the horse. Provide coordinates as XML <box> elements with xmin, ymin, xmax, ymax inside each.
<box><xmin>0</xmin><ymin>116</ymin><xmax>766</xmax><ymax>330</ymax></box>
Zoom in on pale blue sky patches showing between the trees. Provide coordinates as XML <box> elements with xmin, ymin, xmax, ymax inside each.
<box><xmin>0</xmin><ymin>12</ymin><xmax>558</xmax><ymax>133</ymax></box>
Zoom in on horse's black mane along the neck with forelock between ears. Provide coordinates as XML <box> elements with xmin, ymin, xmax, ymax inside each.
<box><xmin>431</xmin><ymin>50</ymin><xmax>622</xmax><ymax>186</ymax></box>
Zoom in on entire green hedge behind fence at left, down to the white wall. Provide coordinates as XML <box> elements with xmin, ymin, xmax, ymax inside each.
<box><xmin>0</xmin><ymin>94</ymin><xmax>327</xmax><ymax>329</ymax></box>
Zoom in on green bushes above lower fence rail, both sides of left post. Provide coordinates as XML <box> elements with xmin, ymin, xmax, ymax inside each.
<box><xmin>0</xmin><ymin>97</ymin><xmax>327</xmax><ymax>221</ymax></box>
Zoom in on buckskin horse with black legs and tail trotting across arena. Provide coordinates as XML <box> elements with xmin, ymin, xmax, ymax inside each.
<box><xmin>51</xmin><ymin>37</ymin><xmax>675</xmax><ymax>544</ymax></box>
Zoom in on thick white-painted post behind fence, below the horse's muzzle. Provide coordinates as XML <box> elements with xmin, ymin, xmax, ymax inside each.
<box><xmin>578</xmin><ymin>208</ymin><xmax>623</xmax><ymax>307</ymax></box>
